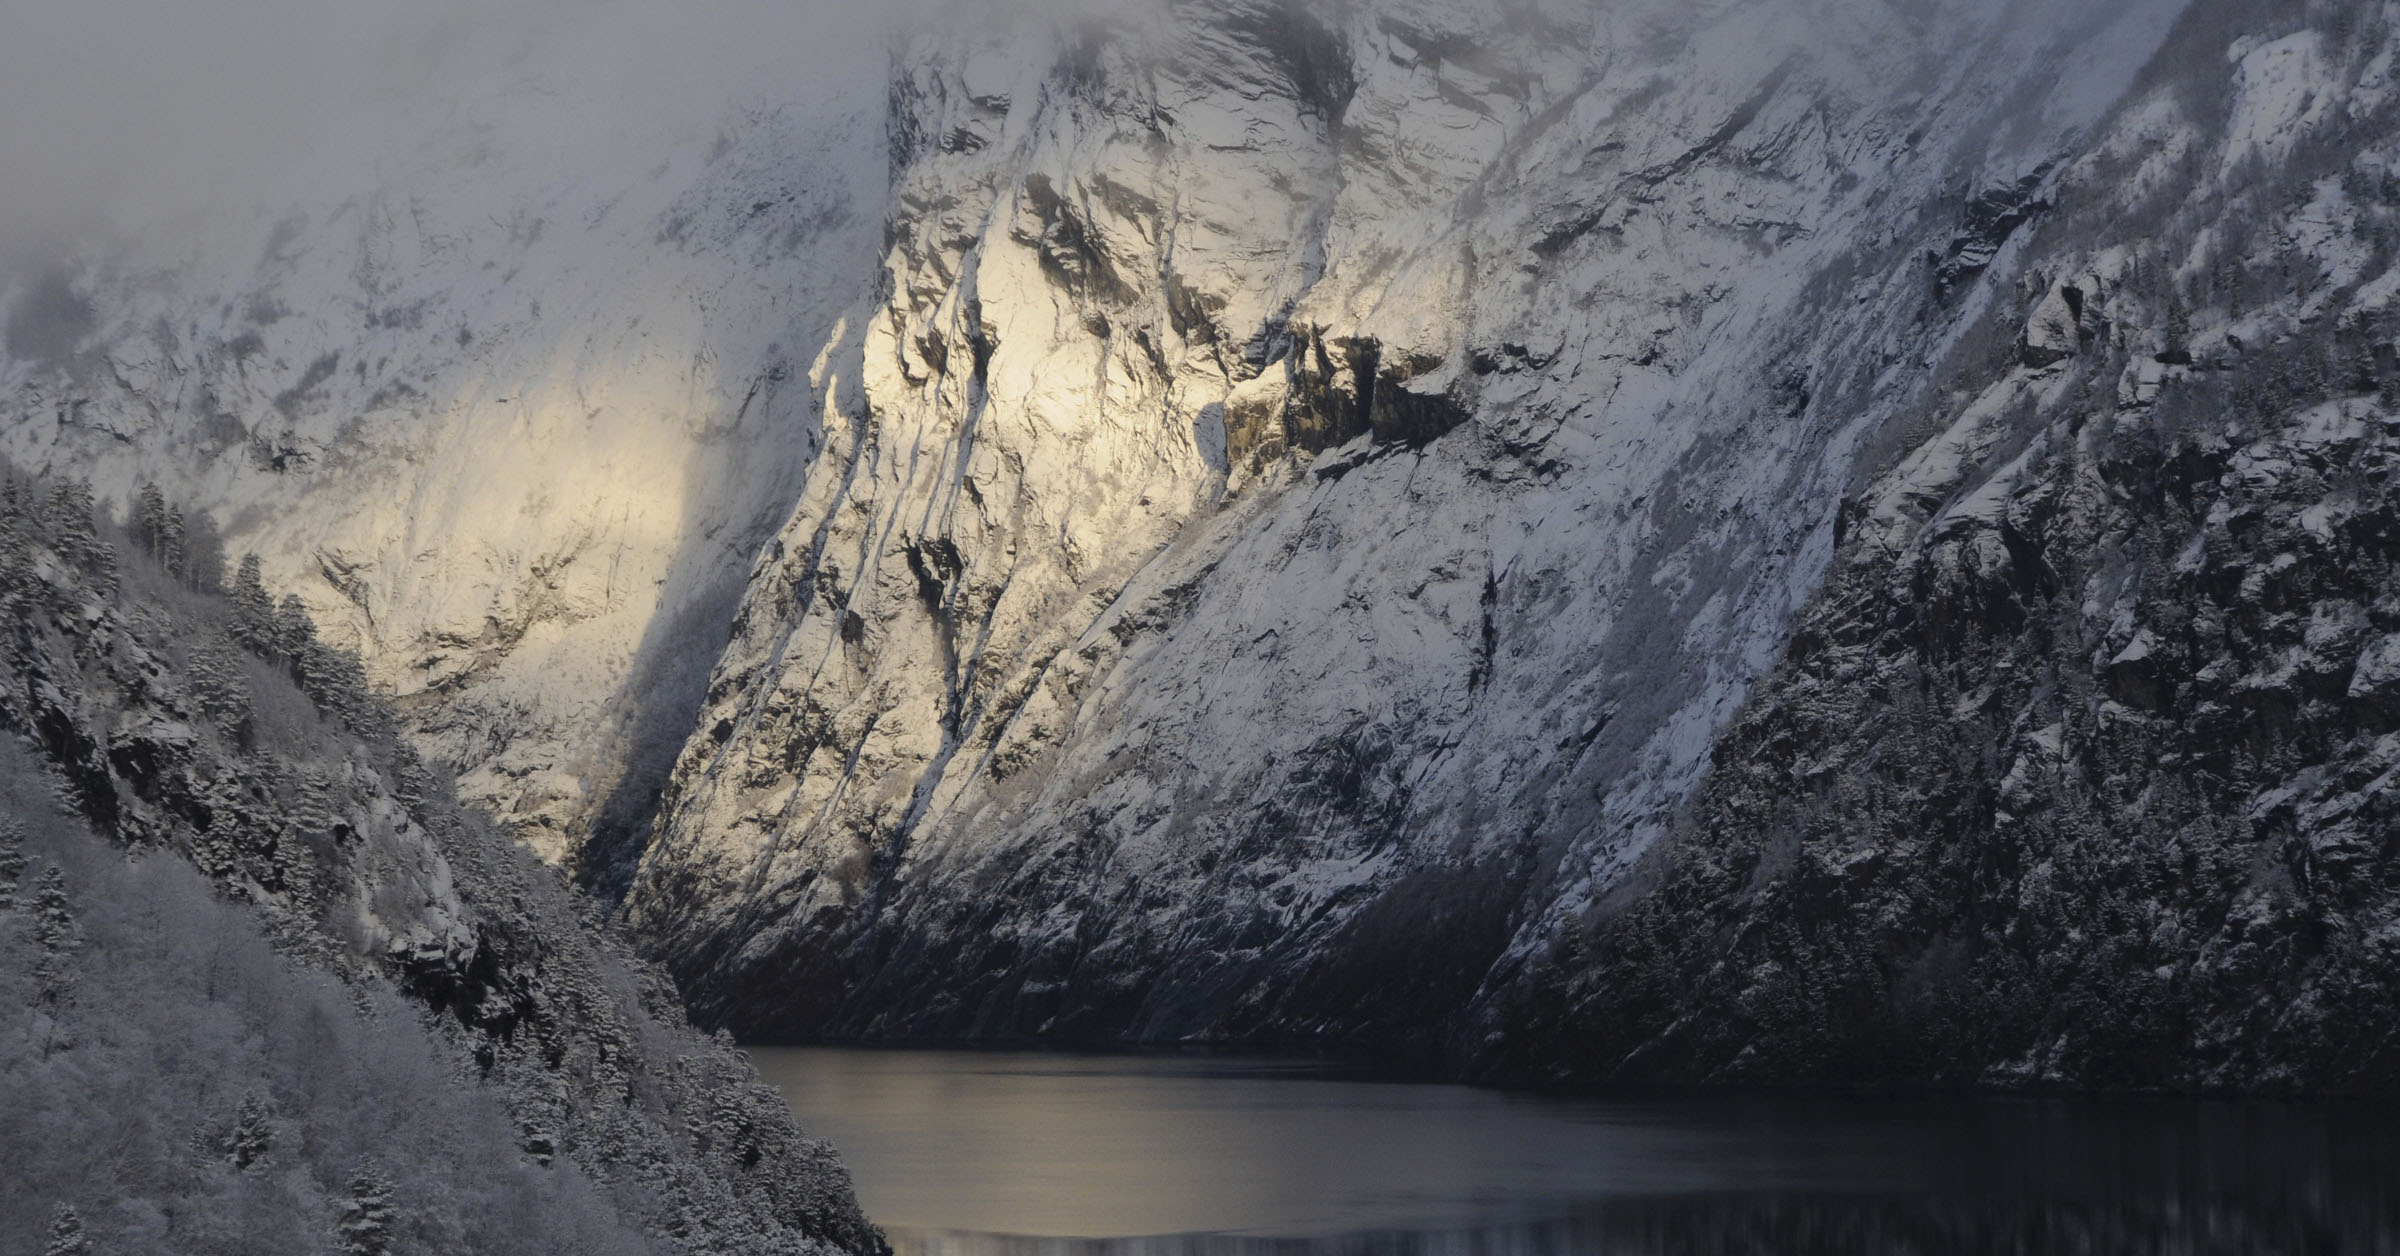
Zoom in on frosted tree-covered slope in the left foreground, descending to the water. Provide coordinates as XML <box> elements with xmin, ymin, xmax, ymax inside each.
<box><xmin>0</xmin><ymin>476</ymin><xmax>881</xmax><ymax>1254</ymax></box>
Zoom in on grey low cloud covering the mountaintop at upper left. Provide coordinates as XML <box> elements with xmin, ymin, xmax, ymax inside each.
<box><xmin>0</xmin><ymin>0</ymin><xmax>883</xmax><ymax>283</ymax></box>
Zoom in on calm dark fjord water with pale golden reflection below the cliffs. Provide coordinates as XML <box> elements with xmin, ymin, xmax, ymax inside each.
<box><xmin>751</xmin><ymin>1047</ymin><xmax>2400</xmax><ymax>1256</ymax></box>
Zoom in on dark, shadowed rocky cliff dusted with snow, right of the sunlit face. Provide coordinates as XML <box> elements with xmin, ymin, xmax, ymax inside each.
<box><xmin>1483</xmin><ymin>5</ymin><xmax>2400</xmax><ymax>1090</ymax></box>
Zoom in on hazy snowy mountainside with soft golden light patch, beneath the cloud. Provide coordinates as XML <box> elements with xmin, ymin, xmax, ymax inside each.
<box><xmin>0</xmin><ymin>5</ymin><xmax>886</xmax><ymax>879</ymax></box>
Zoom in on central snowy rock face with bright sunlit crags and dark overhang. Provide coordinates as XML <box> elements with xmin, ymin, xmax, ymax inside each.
<box><xmin>626</xmin><ymin>0</ymin><xmax>2182</xmax><ymax>1040</ymax></box>
